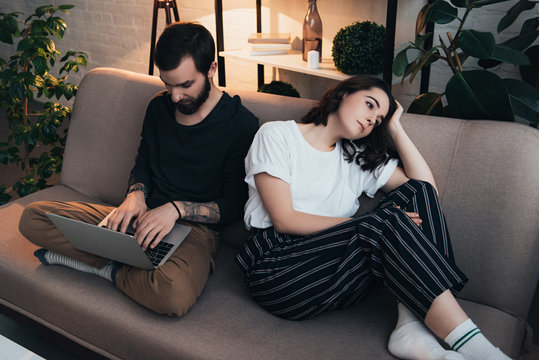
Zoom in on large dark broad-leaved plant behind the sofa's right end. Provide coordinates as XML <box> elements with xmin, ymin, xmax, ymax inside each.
<box><xmin>393</xmin><ymin>0</ymin><xmax>539</xmax><ymax>123</ymax></box>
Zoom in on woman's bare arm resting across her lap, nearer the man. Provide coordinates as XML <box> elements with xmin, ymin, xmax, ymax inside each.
<box><xmin>255</xmin><ymin>172</ymin><xmax>350</xmax><ymax>235</ymax></box>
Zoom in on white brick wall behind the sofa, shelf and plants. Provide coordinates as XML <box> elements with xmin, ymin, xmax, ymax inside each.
<box><xmin>0</xmin><ymin>0</ymin><xmax>531</xmax><ymax>106</ymax></box>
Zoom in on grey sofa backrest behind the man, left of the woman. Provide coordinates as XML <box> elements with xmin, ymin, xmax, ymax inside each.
<box><xmin>61</xmin><ymin>68</ymin><xmax>315</xmax><ymax>204</ymax></box>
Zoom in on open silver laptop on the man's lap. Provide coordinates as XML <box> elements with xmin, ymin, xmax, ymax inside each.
<box><xmin>46</xmin><ymin>213</ymin><xmax>191</xmax><ymax>270</ymax></box>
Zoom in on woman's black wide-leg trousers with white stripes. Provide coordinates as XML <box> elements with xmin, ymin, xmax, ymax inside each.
<box><xmin>236</xmin><ymin>180</ymin><xmax>467</xmax><ymax>320</ymax></box>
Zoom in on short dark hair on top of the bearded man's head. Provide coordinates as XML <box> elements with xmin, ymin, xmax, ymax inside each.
<box><xmin>154</xmin><ymin>22</ymin><xmax>215</xmax><ymax>74</ymax></box>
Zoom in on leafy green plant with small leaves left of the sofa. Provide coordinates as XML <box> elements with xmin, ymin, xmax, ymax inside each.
<box><xmin>0</xmin><ymin>5</ymin><xmax>87</xmax><ymax>204</ymax></box>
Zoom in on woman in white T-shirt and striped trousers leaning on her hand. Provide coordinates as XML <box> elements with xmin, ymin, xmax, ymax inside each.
<box><xmin>236</xmin><ymin>76</ymin><xmax>508</xmax><ymax>359</ymax></box>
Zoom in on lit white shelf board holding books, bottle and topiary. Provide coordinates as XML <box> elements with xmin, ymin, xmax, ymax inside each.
<box><xmin>219</xmin><ymin>50</ymin><xmax>350</xmax><ymax>81</ymax></box>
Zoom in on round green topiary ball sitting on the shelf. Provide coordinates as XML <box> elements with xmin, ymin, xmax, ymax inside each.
<box><xmin>331</xmin><ymin>21</ymin><xmax>386</xmax><ymax>75</ymax></box>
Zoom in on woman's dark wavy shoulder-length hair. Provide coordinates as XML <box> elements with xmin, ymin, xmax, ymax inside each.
<box><xmin>301</xmin><ymin>75</ymin><xmax>398</xmax><ymax>171</ymax></box>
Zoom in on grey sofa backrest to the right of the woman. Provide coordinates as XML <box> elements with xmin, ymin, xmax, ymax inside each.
<box><xmin>403</xmin><ymin>114</ymin><xmax>539</xmax><ymax>319</ymax></box>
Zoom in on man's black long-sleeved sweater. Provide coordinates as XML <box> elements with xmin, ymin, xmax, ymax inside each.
<box><xmin>129</xmin><ymin>91</ymin><xmax>258</xmax><ymax>228</ymax></box>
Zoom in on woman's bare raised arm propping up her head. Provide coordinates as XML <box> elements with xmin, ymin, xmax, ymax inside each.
<box><xmin>383</xmin><ymin>102</ymin><xmax>436</xmax><ymax>192</ymax></box>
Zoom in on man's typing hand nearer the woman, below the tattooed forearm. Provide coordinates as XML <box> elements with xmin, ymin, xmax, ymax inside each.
<box><xmin>134</xmin><ymin>203</ymin><xmax>178</xmax><ymax>250</ymax></box>
